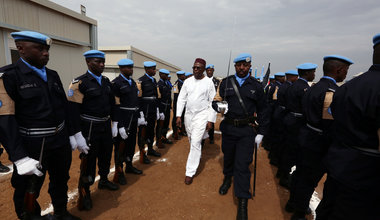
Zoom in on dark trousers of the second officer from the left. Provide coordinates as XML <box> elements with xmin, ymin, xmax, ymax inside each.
<box><xmin>82</xmin><ymin>121</ymin><xmax>113</xmax><ymax>181</ymax></box>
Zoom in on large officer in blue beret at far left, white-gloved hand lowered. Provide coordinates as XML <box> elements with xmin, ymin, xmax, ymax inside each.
<box><xmin>0</xmin><ymin>31</ymin><xmax>79</xmax><ymax>219</ymax></box>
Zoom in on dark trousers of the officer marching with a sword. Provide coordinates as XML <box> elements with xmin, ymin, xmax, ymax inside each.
<box><xmin>221</xmin><ymin>122</ymin><xmax>256</xmax><ymax>198</ymax></box>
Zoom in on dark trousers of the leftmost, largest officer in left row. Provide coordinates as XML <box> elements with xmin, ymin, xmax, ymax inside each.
<box><xmin>11</xmin><ymin>137</ymin><xmax>72</xmax><ymax>218</ymax></box>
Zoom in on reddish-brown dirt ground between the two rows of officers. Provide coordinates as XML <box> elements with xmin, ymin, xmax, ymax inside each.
<box><xmin>0</xmin><ymin>116</ymin><xmax>322</xmax><ymax>220</ymax></box>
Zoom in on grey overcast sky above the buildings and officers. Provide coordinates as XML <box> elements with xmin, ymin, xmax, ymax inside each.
<box><xmin>52</xmin><ymin>0</ymin><xmax>380</xmax><ymax>78</ymax></box>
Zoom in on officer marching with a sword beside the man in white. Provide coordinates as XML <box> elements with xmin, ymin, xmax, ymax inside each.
<box><xmin>213</xmin><ymin>53</ymin><xmax>269</xmax><ymax>220</ymax></box>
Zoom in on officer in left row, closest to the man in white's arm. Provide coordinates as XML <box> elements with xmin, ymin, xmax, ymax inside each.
<box><xmin>172</xmin><ymin>70</ymin><xmax>186</xmax><ymax>140</ymax></box>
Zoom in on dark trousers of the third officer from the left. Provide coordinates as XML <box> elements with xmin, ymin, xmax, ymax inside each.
<box><xmin>114</xmin><ymin>121</ymin><xmax>137</xmax><ymax>167</ymax></box>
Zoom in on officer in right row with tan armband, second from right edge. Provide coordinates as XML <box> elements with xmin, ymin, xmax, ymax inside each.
<box><xmin>291</xmin><ymin>55</ymin><xmax>353</xmax><ymax>220</ymax></box>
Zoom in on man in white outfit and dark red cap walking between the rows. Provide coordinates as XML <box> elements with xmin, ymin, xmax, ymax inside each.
<box><xmin>176</xmin><ymin>58</ymin><xmax>216</xmax><ymax>185</ymax></box>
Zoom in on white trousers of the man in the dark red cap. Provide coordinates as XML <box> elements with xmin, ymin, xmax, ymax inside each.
<box><xmin>185</xmin><ymin>111</ymin><xmax>208</xmax><ymax>177</ymax></box>
